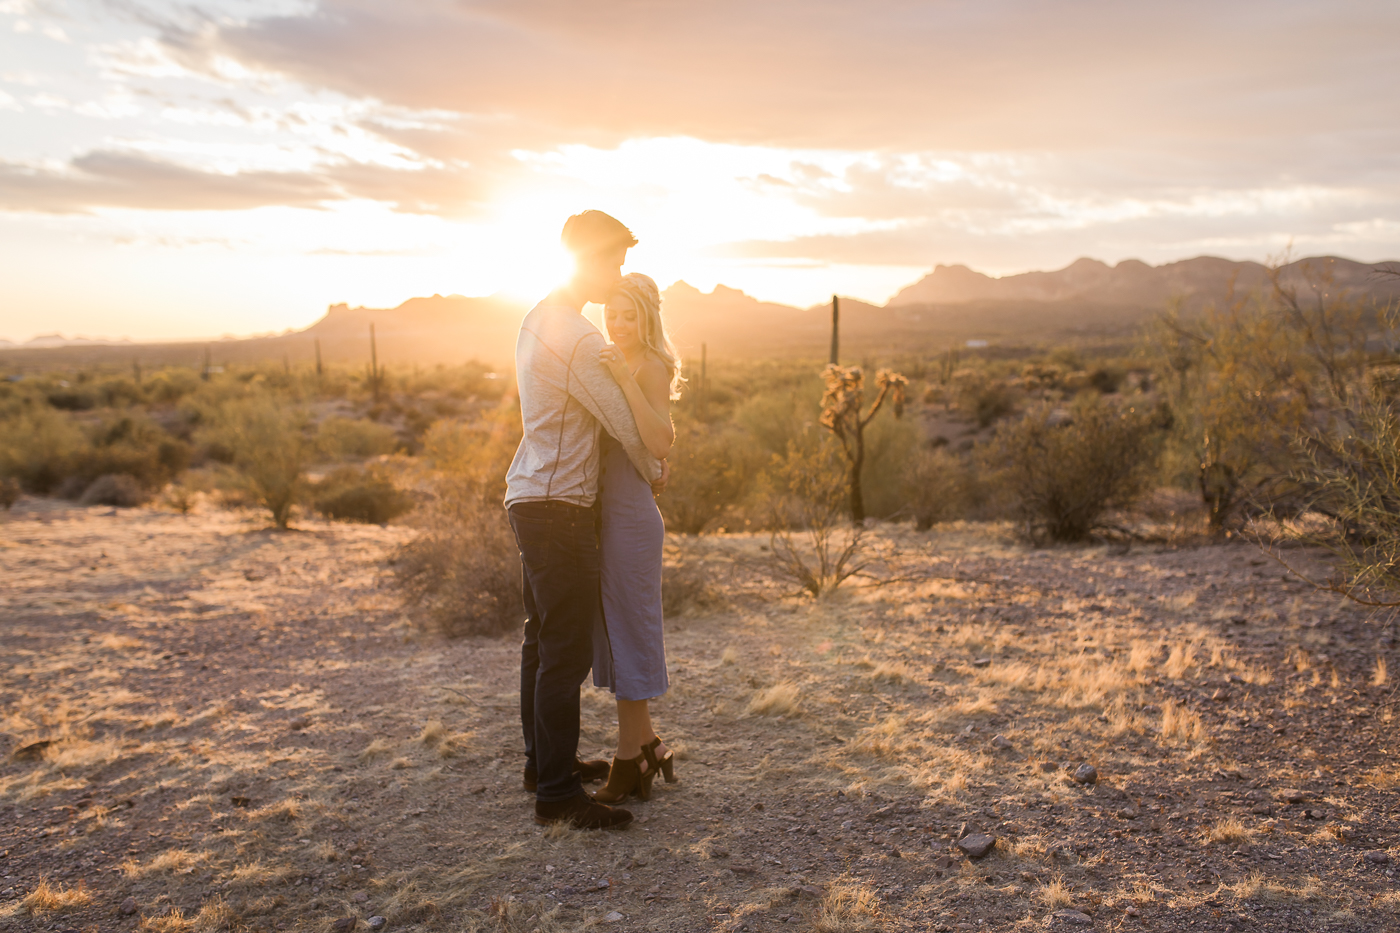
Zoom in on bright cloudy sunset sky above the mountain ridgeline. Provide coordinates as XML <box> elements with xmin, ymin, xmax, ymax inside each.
<box><xmin>0</xmin><ymin>0</ymin><xmax>1400</xmax><ymax>342</ymax></box>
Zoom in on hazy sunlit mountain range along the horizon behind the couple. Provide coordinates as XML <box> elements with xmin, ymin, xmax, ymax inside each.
<box><xmin>0</xmin><ymin>256</ymin><xmax>1400</xmax><ymax>367</ymax></box>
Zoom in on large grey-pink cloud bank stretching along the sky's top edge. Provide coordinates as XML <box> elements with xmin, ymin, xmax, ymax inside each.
<box><xmin>204</xmin><ymin>0</ymin><xmax>1400</xmax><ymax>150</ymax></box>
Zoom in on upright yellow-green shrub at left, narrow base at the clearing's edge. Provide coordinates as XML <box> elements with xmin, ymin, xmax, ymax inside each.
<box><xmin>200</xmin><ymin>395</ymin><xmax>314</xmax><ymax>528</ymax></box>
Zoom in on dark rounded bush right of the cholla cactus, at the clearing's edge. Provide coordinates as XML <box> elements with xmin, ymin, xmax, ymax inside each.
<box><xmin>984</xmin><ymin>395</ymin><xmax>1161</xmax><ymax>541</ymax></box>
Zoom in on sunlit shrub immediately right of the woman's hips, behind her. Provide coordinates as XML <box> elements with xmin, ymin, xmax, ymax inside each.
<box><xmin>657</xmin><ymin>422</ymin><xmax>757</xmax><ymax>535</ymax></box>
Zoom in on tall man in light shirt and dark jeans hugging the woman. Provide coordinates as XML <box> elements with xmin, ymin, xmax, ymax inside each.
<box><xmin>505</xmin><ymin>210</ymin><xmax>665</xmax><ymax>829</ymax></box>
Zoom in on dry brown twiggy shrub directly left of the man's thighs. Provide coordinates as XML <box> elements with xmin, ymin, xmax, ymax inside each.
<box><xmin>393</xmin><ymin>478</ymin><xmax>524</xmax><ymax>637</ymax></box>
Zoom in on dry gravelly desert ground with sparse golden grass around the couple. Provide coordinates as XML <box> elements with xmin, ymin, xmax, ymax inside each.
<box><xmin>0</xmin><ymin>497</ymin><xmax>1400</xmax><ymax>933</ymax></box>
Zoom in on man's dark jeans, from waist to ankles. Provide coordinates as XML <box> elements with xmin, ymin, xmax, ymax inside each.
<box><xmin>510</xmin><ymin>502</ymin><xmax>602</xmax><ymax>801</ymax></box>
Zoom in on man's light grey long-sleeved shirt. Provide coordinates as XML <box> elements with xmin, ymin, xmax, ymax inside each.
<box><xmin>505</xmin><ymin>303</ymin><xmax>661</xmax><ymax>507</ymax></box>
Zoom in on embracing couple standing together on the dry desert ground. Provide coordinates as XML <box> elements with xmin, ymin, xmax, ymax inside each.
<box><xmin>505</xmin><ymin>210</ymin><xmax>682</xmax><ymax>829</ymax></box>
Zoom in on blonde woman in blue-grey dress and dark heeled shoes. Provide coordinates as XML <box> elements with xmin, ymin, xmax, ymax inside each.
<box><xmin>594</xmin><ymin>272</ymin><xmax>683</xmax><ymax>803</ymax></box>
